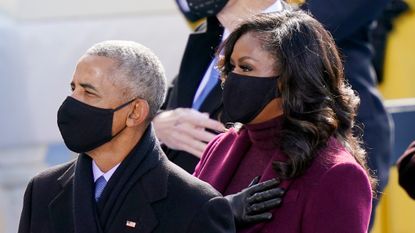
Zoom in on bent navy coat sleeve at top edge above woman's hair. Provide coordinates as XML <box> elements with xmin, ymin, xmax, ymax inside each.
<box><xmin>301</xmin><ymin>0</ymin><xmax>389</xmax><ymax>41</ymax></box>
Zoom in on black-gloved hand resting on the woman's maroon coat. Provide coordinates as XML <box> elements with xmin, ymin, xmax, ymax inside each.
<box><xmin>225</xmin><ymin>176</ymin><xmax>284</xmax><ymax>227</ymax></box>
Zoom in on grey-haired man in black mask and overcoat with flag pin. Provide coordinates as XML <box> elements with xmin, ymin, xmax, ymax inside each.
<box><xmin>19</xmin><ymin>41</ymin><xmax>235</xmax><ymax>233</ymax></box>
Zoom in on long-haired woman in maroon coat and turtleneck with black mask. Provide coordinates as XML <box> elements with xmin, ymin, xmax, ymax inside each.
<box><xmin>194</xmin><ymin>11</ymin><xmax>375</xmax><ymax>233</ymax></box>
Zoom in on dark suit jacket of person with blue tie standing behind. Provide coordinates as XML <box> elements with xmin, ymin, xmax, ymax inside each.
<box><xmin>163</xmin><ymin>17</ymin><xmax>226</xmax><ymax>173</ymax></box>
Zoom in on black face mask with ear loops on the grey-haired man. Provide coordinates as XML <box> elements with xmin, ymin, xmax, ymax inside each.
<box><xmin>58</xmin><ymin>96</ymin><xmax>135</xmax><ymax>153</ymax></box>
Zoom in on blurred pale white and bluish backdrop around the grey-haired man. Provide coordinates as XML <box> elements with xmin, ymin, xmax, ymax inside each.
<box><xmin>0</xmin><ymin>0</ymin><xmax>190</xmax><ymax>233</ymax></box>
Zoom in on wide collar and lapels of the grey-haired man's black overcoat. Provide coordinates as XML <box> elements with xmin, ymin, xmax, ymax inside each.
<box><xmin>49</xmin><ymin>126</ymin><xmax>168</xmax><ymax>233</ymax></box>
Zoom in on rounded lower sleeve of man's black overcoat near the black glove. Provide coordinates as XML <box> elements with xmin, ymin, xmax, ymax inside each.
<box><xmin>187</xmin><ymin>197</ymin><xmax>236</xmax><ymax>233</ymax></box>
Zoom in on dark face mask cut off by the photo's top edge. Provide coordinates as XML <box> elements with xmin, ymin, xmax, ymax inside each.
<box><xmin>176</xmin><ymin>0</ymin><xmax>228</xmax><ymax>22</ymax></box>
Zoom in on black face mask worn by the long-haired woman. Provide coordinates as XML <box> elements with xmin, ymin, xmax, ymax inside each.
<box><xmin>222</xmin><ymin>72</ymin><xmax>280</xmax><ymax>124</ymax></box>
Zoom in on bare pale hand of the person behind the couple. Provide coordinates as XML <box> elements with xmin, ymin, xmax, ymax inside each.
<box><xmin>153</xmin><ymin>108</ymin><xmax>225</xmax><ymax>158</ymax></box>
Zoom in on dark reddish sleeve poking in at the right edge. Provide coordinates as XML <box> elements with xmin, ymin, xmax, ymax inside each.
<box><xmin>397</xmin><ymin>141</ymin><xmax>415</xmax><ymax>199</ymax></box>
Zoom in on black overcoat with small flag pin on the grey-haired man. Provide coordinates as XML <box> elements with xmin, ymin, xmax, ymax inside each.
<box><xmin>19</xmin><ymin>125</ymin><xmax>235</xmax><ymax>233</ymax></box>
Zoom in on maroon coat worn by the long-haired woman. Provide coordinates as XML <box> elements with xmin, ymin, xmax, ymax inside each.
<box><xmin>194</xmin><ymin>118</ymin><xmax>372</xmax><ymax>233</ymax></box>
